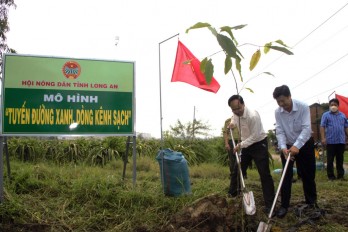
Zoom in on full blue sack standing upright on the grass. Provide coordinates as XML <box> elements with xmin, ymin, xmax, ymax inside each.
<box><xmin>156</xmin><ymin>148</ymin><xmax>191</xmax><ymax>196</ymax></box>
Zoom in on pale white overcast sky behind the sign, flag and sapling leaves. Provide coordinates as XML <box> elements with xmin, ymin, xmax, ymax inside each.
<box><xmin>8</xmin><ymin>0</ymin><xmax>348</xmax><ymax>137</ymax></box>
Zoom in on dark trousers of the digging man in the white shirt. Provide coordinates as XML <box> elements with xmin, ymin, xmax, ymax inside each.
<box><xmin>231</xmin><ymin>138</ymin><xmax>274</xmax><ymax>208</ymax></box>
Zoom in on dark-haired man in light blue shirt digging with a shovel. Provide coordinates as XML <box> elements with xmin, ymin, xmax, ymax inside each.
<box><xmin>273</xmin><ymin>85</ymin><xmax>318</xmax><ymax>218</ymax></box>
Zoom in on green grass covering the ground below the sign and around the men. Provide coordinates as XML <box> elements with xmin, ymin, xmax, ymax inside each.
<box><xmin>0</xmin><ymin>157</ymin><xmax>348</xmax><ymax>231</ymax></box>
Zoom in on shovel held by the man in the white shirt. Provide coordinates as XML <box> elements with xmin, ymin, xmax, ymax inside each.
<box><xmin>230</xmin><ymin>129</ymin><xmax>256</xmax><ymax>215</ymax></box>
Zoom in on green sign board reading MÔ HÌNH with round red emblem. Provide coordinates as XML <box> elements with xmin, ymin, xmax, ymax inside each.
<box><xmin>2</xmin><ymin>54</ymin><xmax>135</xmax><ymax>136</ymax></box>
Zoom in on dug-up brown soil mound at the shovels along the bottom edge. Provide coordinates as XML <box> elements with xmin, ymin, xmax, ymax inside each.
<box><xmin>153</xmin><ymin>192</ymin><xmax>348</xmax><ymax>232</ymax></box>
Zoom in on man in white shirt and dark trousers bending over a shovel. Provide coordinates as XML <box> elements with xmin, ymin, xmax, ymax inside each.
<box><xmin>228</xmin><ymin>95</ymin><xmax>274</xmax><ymax>214</ymax></box>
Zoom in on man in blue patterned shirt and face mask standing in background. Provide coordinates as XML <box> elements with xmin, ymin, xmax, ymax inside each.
<box><xmin>320</xmin><ymin>98</ymin><xmax>348</xmax><ymax>180</ymax></box>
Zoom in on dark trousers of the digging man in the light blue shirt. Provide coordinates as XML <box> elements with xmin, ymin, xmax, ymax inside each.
<box><xmin>280</xmin><ymin>138</ymin><xmax>317</xmax><ymax>208</ymax></box>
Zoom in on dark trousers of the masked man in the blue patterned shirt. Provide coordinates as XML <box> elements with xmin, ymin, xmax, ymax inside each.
<box><xmin>326</xmin><ymin>144</ymin><xmax>345</xmax><ymax>179</ymax></box>
